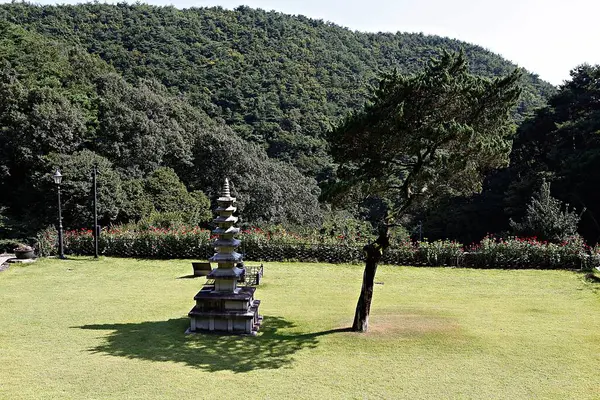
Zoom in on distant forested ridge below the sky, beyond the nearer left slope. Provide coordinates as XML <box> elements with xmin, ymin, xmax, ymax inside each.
<box><xmin>0</xmin><ymin>3</ymin><xmax>553</xmax><ymax>179</ymax></box>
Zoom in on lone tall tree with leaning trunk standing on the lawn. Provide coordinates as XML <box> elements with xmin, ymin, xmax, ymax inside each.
<box><xmin>329</xmin><ymin>52</ymin><xmax>521</xmax><ymax>332</ymax></box>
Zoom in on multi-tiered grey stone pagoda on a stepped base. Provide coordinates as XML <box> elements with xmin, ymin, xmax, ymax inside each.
<box><xmin>188</xmin><ymin>179</ymin><xmax>262</xmax><ymax>335</ymax></box>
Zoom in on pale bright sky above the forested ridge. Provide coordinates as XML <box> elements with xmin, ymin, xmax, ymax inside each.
<box><xmin>5</xmin><ymin>0</ymin><xmax>600</xmax><ymax>85</ymax></box>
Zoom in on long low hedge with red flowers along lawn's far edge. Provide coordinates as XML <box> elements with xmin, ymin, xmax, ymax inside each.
<box><xmin>38</xmin><ymin>229</ymin><xmax>600</xmax><ymax>270</ymax></box>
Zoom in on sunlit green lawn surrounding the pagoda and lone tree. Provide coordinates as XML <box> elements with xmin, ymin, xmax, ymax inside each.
<box><xmin>0</xmin><ymin>258</ymin><xmax>600</xmax><ymax>399</ymax></box>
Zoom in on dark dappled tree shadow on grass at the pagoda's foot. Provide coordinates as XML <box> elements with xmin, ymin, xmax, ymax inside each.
<box><xmin>79</xmin><ymin>316</ymin><xmax>350</xmax><ymax>373</ymax></box>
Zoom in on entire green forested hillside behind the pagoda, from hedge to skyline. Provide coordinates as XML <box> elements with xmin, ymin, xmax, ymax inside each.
<box><xmin>0</xmin><ymin>3</ymin><xmax>568</xmax><ymax>242</ymax></box>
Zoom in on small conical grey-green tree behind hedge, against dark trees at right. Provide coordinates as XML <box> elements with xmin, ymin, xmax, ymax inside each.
<box><xmin>510</xmin><ymin>181</ymin><xmax>581</xmax><ymax>242</ymax></box>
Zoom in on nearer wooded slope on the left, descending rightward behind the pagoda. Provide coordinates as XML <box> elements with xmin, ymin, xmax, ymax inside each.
<box><xmin>0</xmin><ymin>22</ymin><xmax>320</xmax><ymax>235</ymax></box>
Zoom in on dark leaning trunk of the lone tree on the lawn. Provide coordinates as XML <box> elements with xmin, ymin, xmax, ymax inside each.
<box><xmin>352</xmin><ymin>228</ymin><xmax>389</xmax><ymax>332</ymax></box>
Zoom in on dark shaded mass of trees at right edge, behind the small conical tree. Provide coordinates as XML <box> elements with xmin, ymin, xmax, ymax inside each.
<box><xmin>420</xmin><ymin>65</ymin><xmax>600</xmax><ymax>243</ymax></box>
